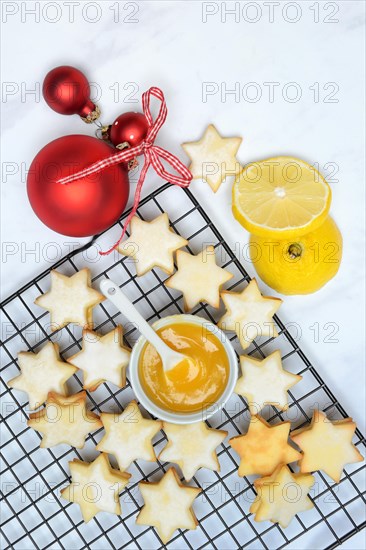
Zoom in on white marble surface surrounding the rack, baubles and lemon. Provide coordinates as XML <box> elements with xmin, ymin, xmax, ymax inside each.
<box><xmin>1</xmin><ymin>1</ymin><xmax>365</xmax><ymax>548</ymax></box>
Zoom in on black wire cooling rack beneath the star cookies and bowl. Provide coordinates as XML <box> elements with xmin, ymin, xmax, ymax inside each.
<box><xmin>0</xmin><ymin>184</ymin><xmax>366</xmax><ymax>550</ymax></box>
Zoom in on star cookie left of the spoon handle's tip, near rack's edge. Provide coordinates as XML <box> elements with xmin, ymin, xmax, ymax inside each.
<box><xmin>34</xmin><ymin>268</ymin><xmax>104</xmax><ymax>331</ymax></box>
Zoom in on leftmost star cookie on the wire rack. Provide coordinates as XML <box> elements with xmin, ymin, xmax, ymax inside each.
<box><xmin>8</xmin><ymin>342</ymin><xmax>77</xmax><ymax>410</ymax></box>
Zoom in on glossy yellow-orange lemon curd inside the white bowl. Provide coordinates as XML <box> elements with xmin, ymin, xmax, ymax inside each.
<box><xmin>138</xmin><ymin>323</ymin><xmax>229</xmax><ymax>413</ymax></box>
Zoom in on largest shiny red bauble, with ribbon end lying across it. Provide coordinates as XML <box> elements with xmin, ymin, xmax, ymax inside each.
<box><xmin>27</xmin><ymin>135</ymin><xmax>129</xmax><ymax>237</ymax></box>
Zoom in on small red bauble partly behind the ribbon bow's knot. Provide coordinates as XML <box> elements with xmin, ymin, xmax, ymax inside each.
<box><xmin>108</xmin><ymin>113</ymin><xmax>148</xmax><ymax>147</ymax></box>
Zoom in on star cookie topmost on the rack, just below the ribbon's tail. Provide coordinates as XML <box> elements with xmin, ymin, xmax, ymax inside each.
<box><xmin>118</xmin><ymin>213</ymin><xmax>188</xmax><ymax>276</ymax></box>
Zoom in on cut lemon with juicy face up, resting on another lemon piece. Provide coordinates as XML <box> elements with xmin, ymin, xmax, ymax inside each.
<box><xmin>232</xmin><ymin>157</ymin><xmax>331</xmax><ymax>239</ymax></box>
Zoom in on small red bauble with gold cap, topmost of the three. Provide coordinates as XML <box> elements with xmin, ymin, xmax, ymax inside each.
<box><xmin>43</xmin><ymin>65</ymin><xmax>99</xmax><ymax>120</ymax></box>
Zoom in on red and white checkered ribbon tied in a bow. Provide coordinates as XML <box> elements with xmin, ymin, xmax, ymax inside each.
<box><xmin>58</xmin><ymin>87</ymin><xmax>192</xmax><ymax>256</ymax></box>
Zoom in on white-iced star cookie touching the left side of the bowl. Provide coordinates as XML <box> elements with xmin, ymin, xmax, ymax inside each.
<box><xmin>67</xmin><ymin>326</ymin><xmax>130</xmax><ymax>391</ymax></box>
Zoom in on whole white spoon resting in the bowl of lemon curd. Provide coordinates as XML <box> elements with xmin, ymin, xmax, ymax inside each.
<box><xmin>99</xmin><ymin>279</ymin><xmax>188</xmax><ymax>371</ymax></box>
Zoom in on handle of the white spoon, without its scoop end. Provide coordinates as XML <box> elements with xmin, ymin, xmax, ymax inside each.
<box><xmin>99</xmin><ymin>279</ymin><xmax>172</xmax><ymax>357</ymax></box>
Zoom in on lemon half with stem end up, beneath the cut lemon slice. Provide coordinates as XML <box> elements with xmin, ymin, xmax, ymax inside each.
<box><xmin>250</xmin><ymin>216</ymin><xmax>342</xmax><ymax>294</ymax></box>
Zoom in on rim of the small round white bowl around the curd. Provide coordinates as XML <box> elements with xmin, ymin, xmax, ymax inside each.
<box><xmin>129</xmin><ymin>314</ymin><xmax>238</xmax><ymax>424</ymax></box>
